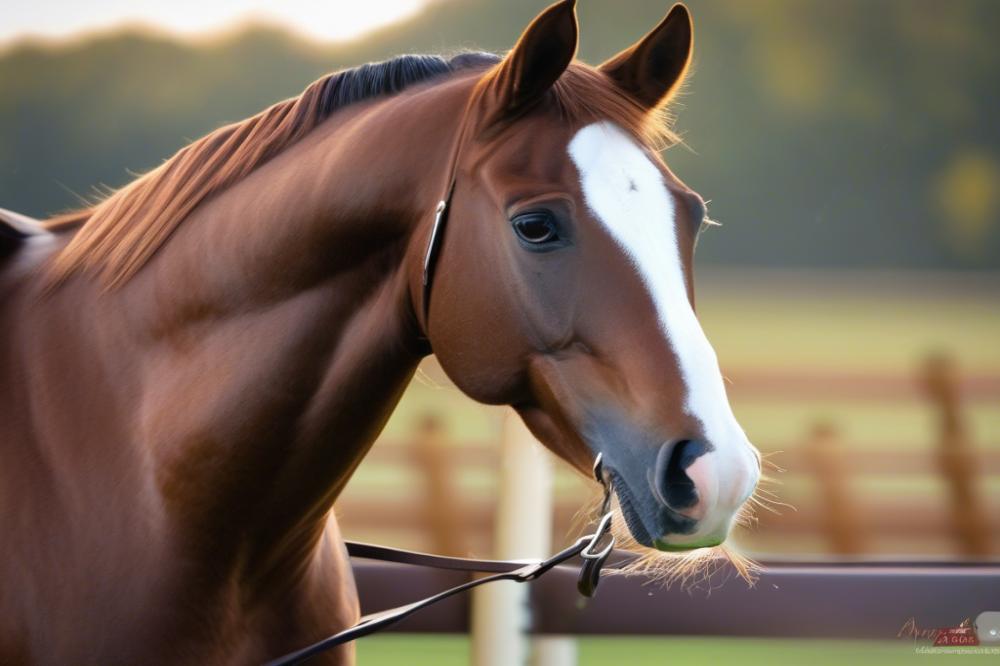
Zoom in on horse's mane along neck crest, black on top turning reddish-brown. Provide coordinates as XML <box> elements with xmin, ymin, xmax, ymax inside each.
<box><xmin>42</xmin><ymin>53</ymin><xmax>499</xmax><ymax>286</ymax></box>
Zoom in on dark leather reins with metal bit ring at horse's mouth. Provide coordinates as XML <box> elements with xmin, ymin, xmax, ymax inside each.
<box><xmin>265</xmin><ymin>454</ymin><xmax>615</xmax><ymax>666</ymax></box>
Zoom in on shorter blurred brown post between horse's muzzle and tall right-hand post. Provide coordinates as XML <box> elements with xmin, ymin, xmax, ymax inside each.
<box><xmin>805</xmin><ymin>422</ymin><xmax>864</xmax><ymax>555</ymax></box>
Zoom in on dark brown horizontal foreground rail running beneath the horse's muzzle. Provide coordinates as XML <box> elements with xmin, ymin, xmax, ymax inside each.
<box><xmin>354</xmin><ymin>560</ymin><xmax>1000</xmax><ymax>640</ymax></box>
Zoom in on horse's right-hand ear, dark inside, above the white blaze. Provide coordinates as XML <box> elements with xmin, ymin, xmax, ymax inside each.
<box><xmin>600</xmin><ymin>4</ymin><xmax>694</xmax><ymax>109</ymax></box>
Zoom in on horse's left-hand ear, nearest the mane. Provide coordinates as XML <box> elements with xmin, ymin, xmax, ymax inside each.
<box><xmin>484</xmin><ymin>0</ymin><xmax>579</xmax><ymax>118</ymax></box>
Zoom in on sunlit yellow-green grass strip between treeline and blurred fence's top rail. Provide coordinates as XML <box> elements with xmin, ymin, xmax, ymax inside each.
<box><xmin>698</xmin><ymin>271</ymin><xmax>1000</xmax><ymax>373</ymax></box>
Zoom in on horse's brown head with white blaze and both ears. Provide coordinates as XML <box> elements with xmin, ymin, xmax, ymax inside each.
<box><xmin>413</xmin><ymin>1</ymin><xmax>760</xmax><ymax>550</ymax></box>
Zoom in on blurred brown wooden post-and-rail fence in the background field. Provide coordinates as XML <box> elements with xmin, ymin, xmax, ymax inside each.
<box><xmin>337</xmin><ymin>357</ymin><xmax>1000</xmax><ymax>558</ymax></box>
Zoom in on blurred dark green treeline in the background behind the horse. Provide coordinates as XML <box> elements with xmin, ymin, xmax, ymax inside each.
<box><xmin>0</xmin><ymin>0</ymin><xmax>1000</xmax><ymax>269</ymax></box>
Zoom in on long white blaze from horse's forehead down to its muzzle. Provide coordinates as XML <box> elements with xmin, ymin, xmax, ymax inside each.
<box><xmin>569</xmin><ymin>122</ymin><xmax>757</xmax><ymax>532</ymax></box>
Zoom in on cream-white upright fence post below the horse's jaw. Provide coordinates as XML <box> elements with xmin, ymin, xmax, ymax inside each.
<box><xmin>471</xmin><ymin>411</ymin><xmax>575</xmax><ymax>666</ymax></box>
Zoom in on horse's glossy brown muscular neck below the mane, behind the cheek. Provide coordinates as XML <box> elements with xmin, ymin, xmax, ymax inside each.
<box><xmin>103</xmin><ymin>74</ymin><xmax>470</xmax><ymax>570</ymax></box>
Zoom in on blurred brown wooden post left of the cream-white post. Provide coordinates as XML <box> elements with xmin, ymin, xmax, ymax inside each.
<box><xmin>413</xmin><ymin>414</ymin><xmax>468</xmax><ymax>557</ymax></box>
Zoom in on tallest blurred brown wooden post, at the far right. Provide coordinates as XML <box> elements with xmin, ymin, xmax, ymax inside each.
<box><xmin>923</xmin><ymin>354</ymin><xmax>991</xmax><ymax>557</ymax></box>
